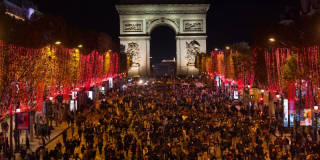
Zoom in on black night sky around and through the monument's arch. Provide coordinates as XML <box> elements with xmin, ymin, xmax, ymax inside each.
<box><xmin>34</xmin><ymin>0</ymin><xmax>300</xmax><ymax>62</ymax></box>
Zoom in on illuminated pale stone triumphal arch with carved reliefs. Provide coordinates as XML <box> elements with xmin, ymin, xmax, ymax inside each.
<box><xmin>116</xmin><ymin>0</ymin><xmax>210</xmax><ymax>77</ymax></box>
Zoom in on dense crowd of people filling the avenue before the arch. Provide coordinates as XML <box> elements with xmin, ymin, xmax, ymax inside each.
<box><xmin>18</xmin><ymin>84</ymin><xmax>320</xmax><ymax>160</ymax></box>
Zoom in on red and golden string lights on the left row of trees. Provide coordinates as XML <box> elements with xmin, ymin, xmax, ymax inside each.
<box><xmin>0</xmin><ymin>40</ymin><xmax>120</xmax><ymax>119</ymax></box>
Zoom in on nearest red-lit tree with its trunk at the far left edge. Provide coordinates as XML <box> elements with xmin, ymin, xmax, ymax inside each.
<box><xmin>0</xmin><ymin>42</ymin><xmax>44</xmax><ymax>151</ymax></box>
